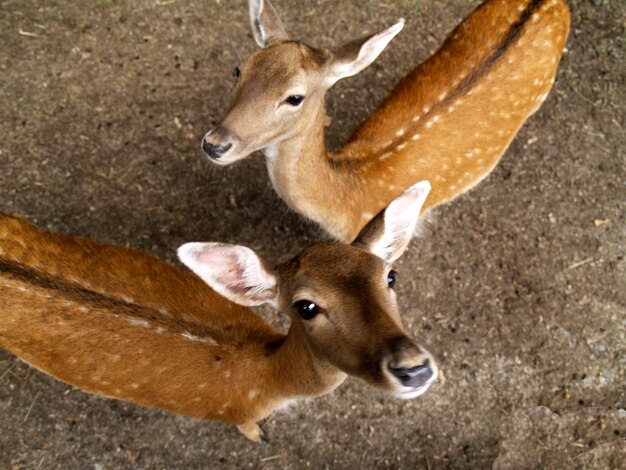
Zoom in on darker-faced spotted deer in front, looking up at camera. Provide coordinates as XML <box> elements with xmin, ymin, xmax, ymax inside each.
<box><xmin>0</xmin><ymin>181</ymin><xmax>438</xmax><ymax>442</ymax></box>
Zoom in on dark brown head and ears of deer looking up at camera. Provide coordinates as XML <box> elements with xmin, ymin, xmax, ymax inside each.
<box><xmin>179</xmin><ymin>181</ymin><xmax>437</xmax><ymax>398</ymax></box>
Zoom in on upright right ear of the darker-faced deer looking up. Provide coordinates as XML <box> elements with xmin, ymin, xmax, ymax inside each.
<box><xmin>352</xmin><ymin>181</ymin><xmax>430</xmax><ymax>263</ymax></box>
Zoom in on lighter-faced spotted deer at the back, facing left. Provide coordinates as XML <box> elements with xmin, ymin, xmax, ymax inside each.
<box><xmin>201</xmin><ymin>0</ymin><xmax>570</xmax><ymax>242</ymax></box>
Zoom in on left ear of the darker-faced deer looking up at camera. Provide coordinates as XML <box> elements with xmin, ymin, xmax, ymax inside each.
<box><xmin>178</xmin><ymin>243</ymin><xmax>278</xmax><ymax>307</ymax></box>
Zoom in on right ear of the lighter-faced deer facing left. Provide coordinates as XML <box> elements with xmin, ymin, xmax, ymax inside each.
<box><xmin>327</xmin><ymin>19</ymin><xmax>404</xmax><ymax>86</ymax></box>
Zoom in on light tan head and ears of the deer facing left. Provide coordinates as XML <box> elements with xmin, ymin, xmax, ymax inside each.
<box><xmin>202</xmin><ymin>0</ymin><xmax>404</xmax><ymax>165</ymax></box>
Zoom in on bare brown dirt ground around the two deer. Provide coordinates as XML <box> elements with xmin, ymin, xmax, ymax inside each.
<box><xmin>0</xmin><ymin>0</ymin><xmax>626</xmax><ymax>469</ymax></box>
